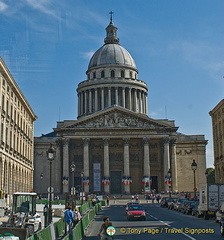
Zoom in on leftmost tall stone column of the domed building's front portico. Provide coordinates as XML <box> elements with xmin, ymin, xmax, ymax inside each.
<box><xmin>63</xmin><ymin>138</ymin><xmax>69</xmax><ymax>193</ymax></box>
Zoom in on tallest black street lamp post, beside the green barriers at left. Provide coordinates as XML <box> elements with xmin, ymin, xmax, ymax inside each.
<box><xmin>47</xmin><ymin>144</ymin><xmax>55</xmax><ymax>224</ymax></box>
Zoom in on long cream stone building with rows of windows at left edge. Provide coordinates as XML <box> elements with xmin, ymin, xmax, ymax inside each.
<box><xmin>0</xmin><ymin>58</ymin><xmax>37</xmax><ymax>194</ymax></box>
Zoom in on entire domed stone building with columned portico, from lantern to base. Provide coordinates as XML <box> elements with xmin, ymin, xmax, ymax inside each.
<box><xmin>34</xmin><ymin>18</ymin><xmax>207</xmax><ymax>194</ymax></box>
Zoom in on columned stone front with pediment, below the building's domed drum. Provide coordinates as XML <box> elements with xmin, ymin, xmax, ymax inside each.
<box><xmin>35</xmin><ymin>106</ymin><xmax>207</xmax><ymax>194</ymax></box>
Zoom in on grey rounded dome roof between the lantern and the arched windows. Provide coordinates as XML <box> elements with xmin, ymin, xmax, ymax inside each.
<box><xmin>88</xmin><ymin>43</ymin><xmax>136</xmax><ymax>70</ymax></box>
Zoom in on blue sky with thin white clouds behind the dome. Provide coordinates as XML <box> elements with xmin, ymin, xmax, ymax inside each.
<box><xmin>0</xmin><ymin>0</ymin><xmax>224</xmax><ymax>167</ymax></box>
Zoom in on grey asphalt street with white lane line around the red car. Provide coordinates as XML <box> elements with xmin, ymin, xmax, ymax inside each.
<box><xmin>83</xmin><ymin>202</ymin><xmax>223</xmax><ymax>240</ymax></box>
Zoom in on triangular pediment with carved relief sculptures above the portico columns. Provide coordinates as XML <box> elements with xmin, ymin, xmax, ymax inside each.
<box><xmin>60</xmin><ymin>106</ymin><xmax>177</xmax><ymax>129</ymax></box>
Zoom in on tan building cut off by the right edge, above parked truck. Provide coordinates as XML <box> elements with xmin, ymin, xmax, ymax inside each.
<box><xmin>209</xmin><ymin>99</ymin><xmax>224</xmax><ymax>184</ymax></box>
